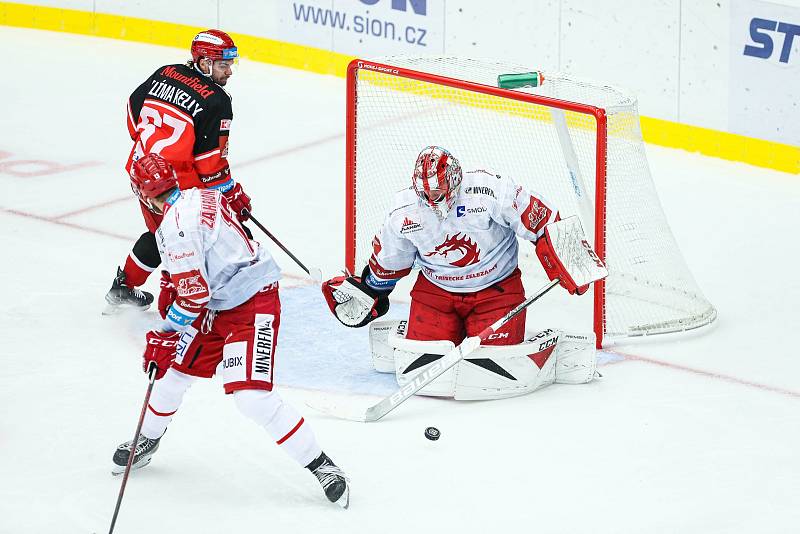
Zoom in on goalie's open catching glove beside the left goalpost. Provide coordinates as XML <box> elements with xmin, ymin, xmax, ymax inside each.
<box><xmin>322</xmin><ymin>267</ymin><xmax>389</xmax><ymax>328</ymax></box>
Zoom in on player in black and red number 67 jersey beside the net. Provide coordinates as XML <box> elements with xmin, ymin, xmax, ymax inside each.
<box><xmin>106</xmin><ymin>30</ymin><xmax>251</xmax><ymax>313</ymax></box>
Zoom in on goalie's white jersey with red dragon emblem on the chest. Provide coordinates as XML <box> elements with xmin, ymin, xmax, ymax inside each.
<box><xmin>366</xmin><ymin>170</ymin><xmax>558</xmax><ymax>293</ymax></box>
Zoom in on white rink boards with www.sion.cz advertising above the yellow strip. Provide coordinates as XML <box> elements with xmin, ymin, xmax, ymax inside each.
<box><xmin>10</xmin><ymin>0</ymin><xmax>800</xmax><ymax>145</ymax></box>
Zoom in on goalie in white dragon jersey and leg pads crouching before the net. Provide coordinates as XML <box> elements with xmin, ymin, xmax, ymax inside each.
<box><xmin>322</xmin><ymin>146</ymin><xmax>595</xmax><ymax>398</ymax></box>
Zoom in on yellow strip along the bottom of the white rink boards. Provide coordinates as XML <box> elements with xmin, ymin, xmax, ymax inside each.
<box><xmin>0</xmin><ymin>2</ymin><xmax>800</xmax><ymax>174</ymax></box>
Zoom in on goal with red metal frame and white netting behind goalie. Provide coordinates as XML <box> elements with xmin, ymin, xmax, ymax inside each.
<box><xmin>345</xmin><ymin>58</ymin><xmax>716</xmax><ymax>347</ymax></box>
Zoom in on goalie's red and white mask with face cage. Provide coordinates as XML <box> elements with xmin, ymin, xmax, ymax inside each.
<box><xmin>412</xmin><ymin>146</ymin><xmax>461</xmax><ymax>220</ymax></box>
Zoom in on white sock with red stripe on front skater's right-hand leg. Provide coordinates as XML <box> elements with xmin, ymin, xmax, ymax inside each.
<box><xmin>233</xmin><ymin>389</ymin><xmax>322</xmax><ymax>467</ymax></box>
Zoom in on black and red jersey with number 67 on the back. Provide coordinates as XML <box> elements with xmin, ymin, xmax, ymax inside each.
<box><xmin>125</xmin><ymin>65</ymin><xmax>233</xmax><ymax>190</ymax></box>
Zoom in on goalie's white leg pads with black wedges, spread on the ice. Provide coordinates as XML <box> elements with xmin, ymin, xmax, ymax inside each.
<box><xmin>369</xmin><ymin>321</ymin><xmax>599</xmax><ymax>400</ymax></box>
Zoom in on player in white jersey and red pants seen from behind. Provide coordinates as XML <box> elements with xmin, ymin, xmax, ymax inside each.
<box><xmin>113</xmin><ymin>154</ymin><xmax>350</xmax><ymax>508</ymax></box>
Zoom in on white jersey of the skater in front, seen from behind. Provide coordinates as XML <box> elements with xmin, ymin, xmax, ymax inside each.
<box><xmin>156</xmin><ymin>188</ymin><xmax>281</xmax><ymax>330</ymax></box>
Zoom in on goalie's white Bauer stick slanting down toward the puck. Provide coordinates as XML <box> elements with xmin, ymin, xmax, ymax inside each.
<box><xmin>309</xmin><ymin>278</ymin><xmax>559</xmax><ymax>423</ymax></box>
